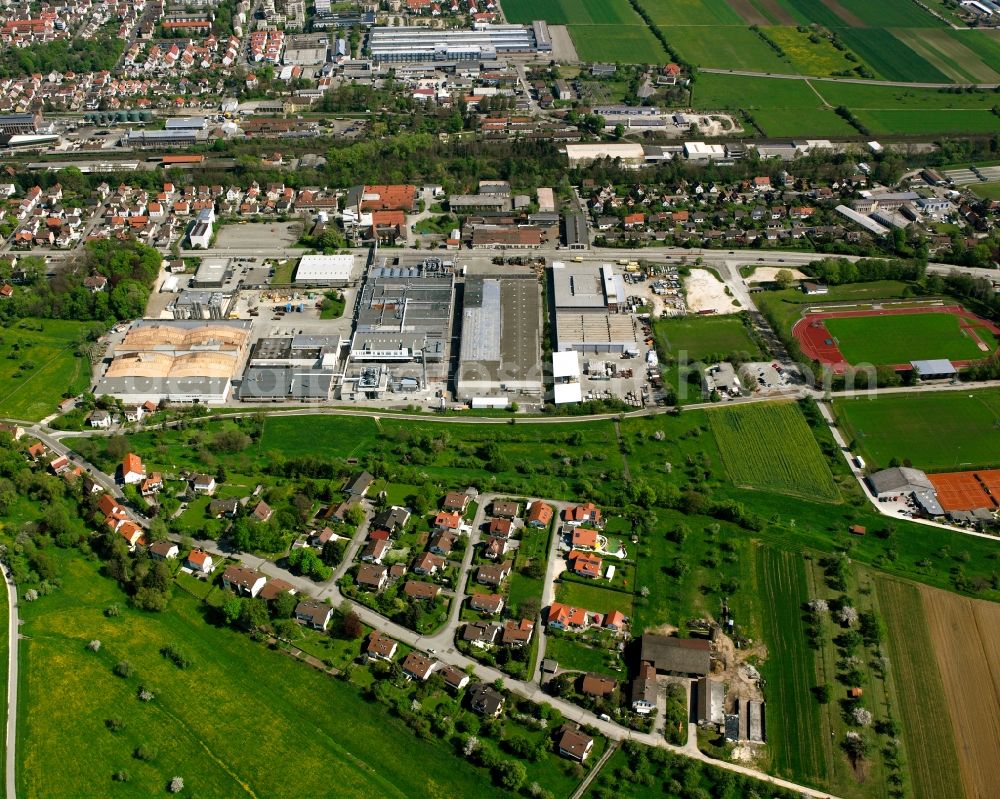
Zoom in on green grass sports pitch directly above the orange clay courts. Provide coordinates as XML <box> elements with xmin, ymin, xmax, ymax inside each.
<box><xmin>834</xmin><ymin>391</ymin><xmax>1000</xmax><ymax>471</ymax></box>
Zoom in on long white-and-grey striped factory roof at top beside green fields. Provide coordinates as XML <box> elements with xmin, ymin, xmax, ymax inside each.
<box><xmin>368</xmin><ymin>22</ymin><xmax>552</xmax><ymax>61</ymax></box>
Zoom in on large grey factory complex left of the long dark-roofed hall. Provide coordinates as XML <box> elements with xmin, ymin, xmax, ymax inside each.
<box><xmin>341</xmin><ymin>258</ymin><xmax>455</xmax><ymax>399</ymax></box>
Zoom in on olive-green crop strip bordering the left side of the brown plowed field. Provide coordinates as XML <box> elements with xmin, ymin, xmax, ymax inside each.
<box><xmin>875</xmin><ymin>578</ymin><xmax>962</xmax><ymax>799</ymax></box>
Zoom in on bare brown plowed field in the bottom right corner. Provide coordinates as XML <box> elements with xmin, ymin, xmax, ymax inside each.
<box><xmin>920</xmin><ymin>586</ymin><xmax>1000</xmax><ymax>799</ymax></box>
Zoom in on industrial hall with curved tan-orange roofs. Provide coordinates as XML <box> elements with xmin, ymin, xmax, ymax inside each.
<box><xmin>94</xmin><ymin>320</ymin><xmax>250</xmax><ymax>404</ymax></box>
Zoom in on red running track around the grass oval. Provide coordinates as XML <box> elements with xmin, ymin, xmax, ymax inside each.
<box><xmin>792</xmin><ymin>305</ymin><xmax>1000</xmax><ymax>374</ymax></box>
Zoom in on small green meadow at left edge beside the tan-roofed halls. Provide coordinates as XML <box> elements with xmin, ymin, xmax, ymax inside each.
<box><xmin>0</xmin><ymin>319</ymin><xmax>90</xmax><ymax>421</ymax></box>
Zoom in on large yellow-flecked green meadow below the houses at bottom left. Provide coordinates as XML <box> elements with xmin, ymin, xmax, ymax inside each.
<box><xmin>18</xmin><ymin>557</ymin><xmax>516</xmax><ymax>799</ymax></box>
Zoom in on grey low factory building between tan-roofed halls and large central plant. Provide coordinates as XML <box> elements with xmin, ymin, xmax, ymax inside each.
<box><xmin>239</xmin><ymin>336</ymin><xmax>343</xmax><ymax>402</ymax></box>
